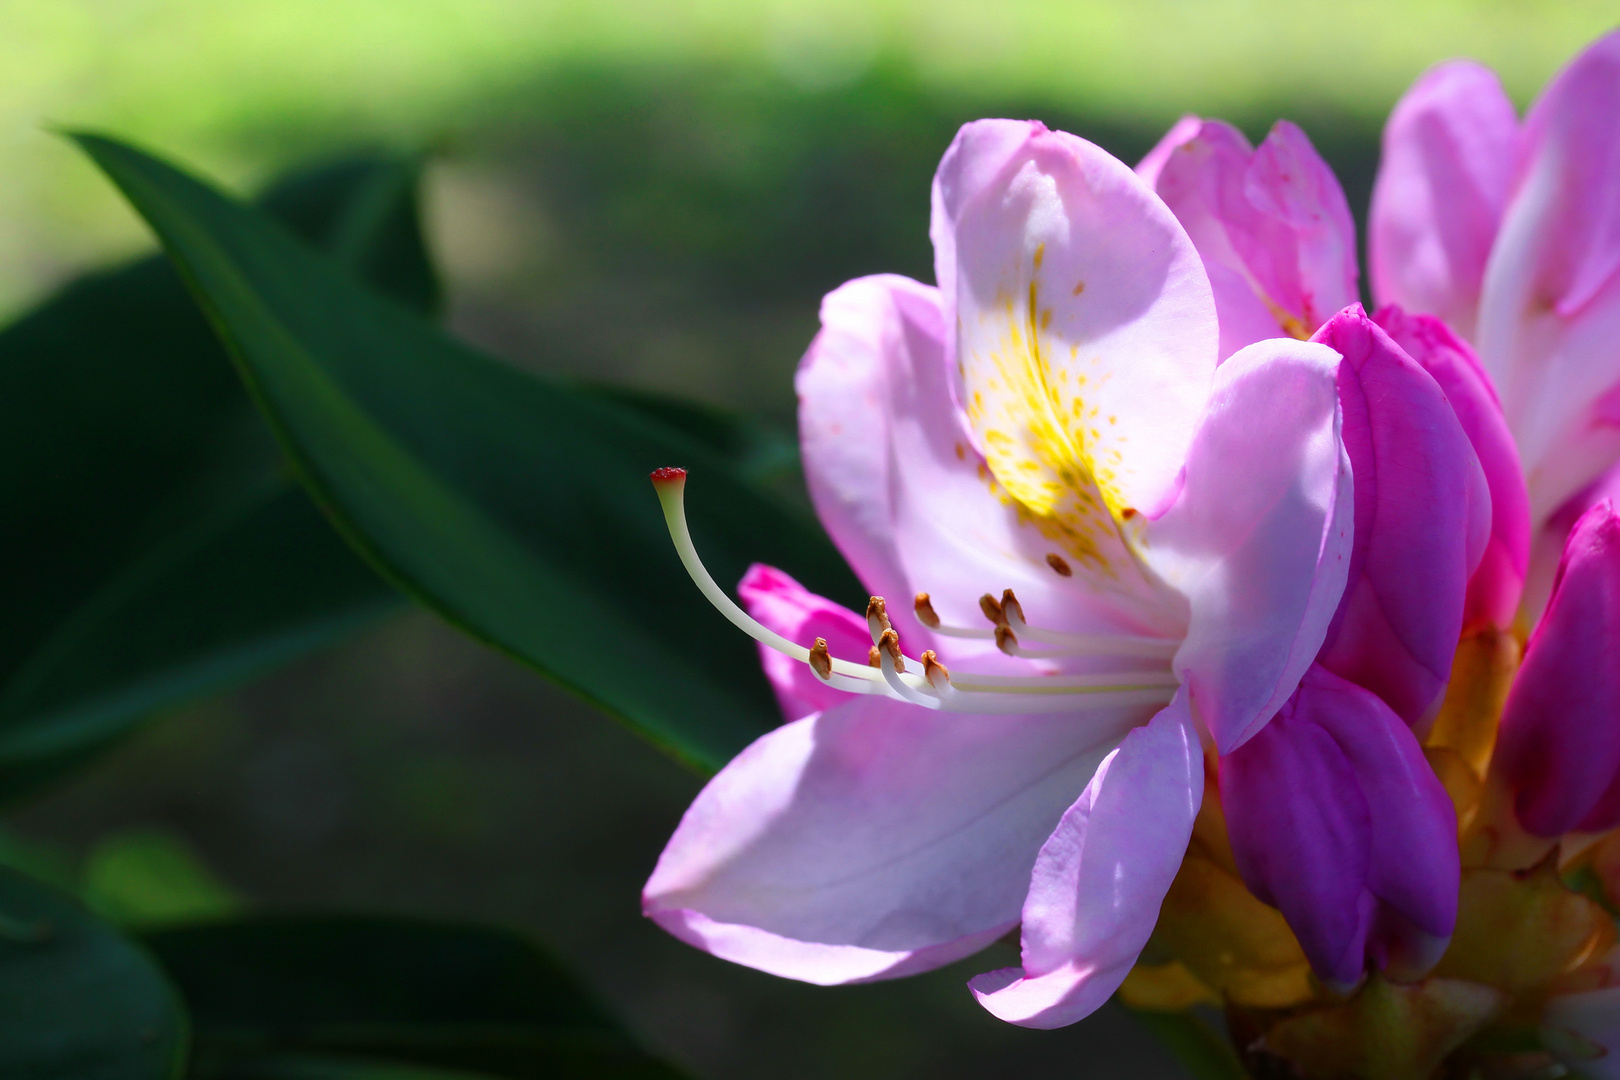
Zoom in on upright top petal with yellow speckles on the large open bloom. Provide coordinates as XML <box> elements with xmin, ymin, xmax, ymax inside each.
<box><xmin>935</xmin><ymin>116</ymin><xmax>1217</xmax><ymax>630</ymax></box>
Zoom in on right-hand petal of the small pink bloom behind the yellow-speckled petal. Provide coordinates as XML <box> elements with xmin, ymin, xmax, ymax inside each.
<box><xmin>1238</xmin><ymin>120</ymin><xmax>1361</xmax><ymax>334</ymax></box>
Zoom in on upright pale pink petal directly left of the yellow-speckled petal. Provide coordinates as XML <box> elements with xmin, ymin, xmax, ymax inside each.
<box><xmin>797</xmin><ymin>275</ymin><xmax>1145</xmax><ymax>647</ymax></box>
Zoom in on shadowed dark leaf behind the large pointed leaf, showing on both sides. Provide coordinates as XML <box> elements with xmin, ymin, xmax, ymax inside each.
<box><xmin>0</xmin><ymin>152</ymin><xmax>437</xmax><ymax>798</ymax></box>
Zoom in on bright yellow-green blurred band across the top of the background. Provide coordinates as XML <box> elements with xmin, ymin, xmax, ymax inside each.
<box><xmin>0</xmin><ymin>0</ymin><xmax>1617</xmax><ymax>313</ymax></box>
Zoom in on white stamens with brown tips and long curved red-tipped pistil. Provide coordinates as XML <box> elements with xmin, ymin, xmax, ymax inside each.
<box><xmin>653</xmin><ymin>468</ymin><xmax>1179</xmax><ymax>712</ymax></box>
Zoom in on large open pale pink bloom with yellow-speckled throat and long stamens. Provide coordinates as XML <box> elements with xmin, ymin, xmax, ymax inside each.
<box><xmin>645</xmin><ymin>120</ymin><xmax>1360</xmax><ymax>1027</ymax></box>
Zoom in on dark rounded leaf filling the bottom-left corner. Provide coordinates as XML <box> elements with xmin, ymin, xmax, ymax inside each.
<box><xmin>0</xmin><ymin>868</ymin><xmax>186</xmax><ymax>1080</ymax></box>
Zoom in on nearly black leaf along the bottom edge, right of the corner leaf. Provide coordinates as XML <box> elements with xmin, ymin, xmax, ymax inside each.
<box><xmin>146</xmin><ymin>916</ymin><xmax>680</xmax><ymax>1080</ymax></box>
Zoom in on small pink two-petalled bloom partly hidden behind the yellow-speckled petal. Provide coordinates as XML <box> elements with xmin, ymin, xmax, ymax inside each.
<box><xmin>1136</xmin><ymin>117</ymin><xmax>1359</xmax><ymax>356</ymax></box>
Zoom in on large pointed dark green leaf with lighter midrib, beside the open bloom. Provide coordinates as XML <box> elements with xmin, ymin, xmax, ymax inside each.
<box><xmin>79</xmin><ymin>136</ymin><xmax>860</xmax><ymax>767</ymax></box>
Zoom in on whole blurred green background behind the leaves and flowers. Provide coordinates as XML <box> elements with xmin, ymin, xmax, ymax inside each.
<box><xmin>0</xmin><ymin>0</ymin><xmax>1615</xmax><ymax>1078</ymax></box>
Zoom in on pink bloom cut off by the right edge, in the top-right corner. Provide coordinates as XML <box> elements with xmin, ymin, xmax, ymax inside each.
<box><xmin>1369</xmin><ymin>31</ymin><xmax>1620</xmax><ymax>586</ymax></box>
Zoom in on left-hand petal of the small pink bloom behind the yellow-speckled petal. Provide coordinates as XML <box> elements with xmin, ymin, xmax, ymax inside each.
<box><xmin>1155</xmin><ymin>120</ymin><xmax>1293</xmax><ymax>359</ymax></box>
